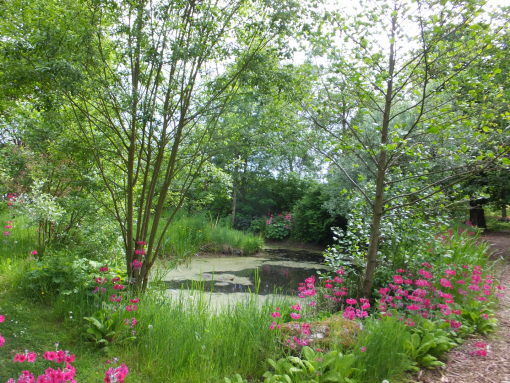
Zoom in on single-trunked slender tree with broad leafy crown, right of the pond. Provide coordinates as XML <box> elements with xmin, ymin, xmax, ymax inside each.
<box><xmin>304</xmin><ymin>0</ymin><xmax>508</xmax><ymax>297</ymax></box>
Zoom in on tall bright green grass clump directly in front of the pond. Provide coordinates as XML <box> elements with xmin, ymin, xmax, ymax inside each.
<box><xmin>126</xmin><ymin>291</ymin><xmax>282</xmax><ymax>382</ymax></box>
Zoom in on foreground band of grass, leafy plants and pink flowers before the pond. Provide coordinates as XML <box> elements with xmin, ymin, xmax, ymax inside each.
<box><xmin>0</xmin><ymin>212</ymin><xmax>501</xmax><ymax>383</ymax></box>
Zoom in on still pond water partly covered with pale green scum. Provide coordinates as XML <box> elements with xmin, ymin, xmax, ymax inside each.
<box><xmin>163</xmin><ymin>247</ymin><xmax>328</xmax><ymax>295</ymax></box>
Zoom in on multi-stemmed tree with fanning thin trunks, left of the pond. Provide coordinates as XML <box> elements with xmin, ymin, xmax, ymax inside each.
<box><xmin>57</xmin><ymin>0</ymin><xmax>304</xmax><ymax>289</ymax></box>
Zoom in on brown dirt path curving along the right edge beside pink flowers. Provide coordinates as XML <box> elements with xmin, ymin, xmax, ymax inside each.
<box><xmin>415</xmin><ymin>231</ymin><xmax>510</xmax><ymax>383</ymax></box>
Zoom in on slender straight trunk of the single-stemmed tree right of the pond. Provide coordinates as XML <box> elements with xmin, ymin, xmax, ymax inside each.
<box><xmin>363</xmin><ymin>8</ymin><xmax>397</xmax><ymax>298</ymax></box>
